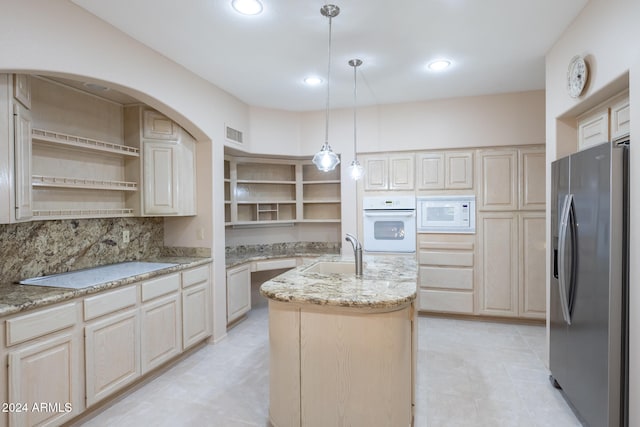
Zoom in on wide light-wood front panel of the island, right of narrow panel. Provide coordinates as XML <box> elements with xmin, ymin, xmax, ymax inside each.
<box><xmin>300</xmin><ymin>308</ymin><xmax>412</xmax><ymax>427</ymax></box>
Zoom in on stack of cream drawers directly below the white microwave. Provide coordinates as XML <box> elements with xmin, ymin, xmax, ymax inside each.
<box><xmin>418</xmin><ymin>233</ymin><xmax>475</xmax><ymax>314</ymax></box>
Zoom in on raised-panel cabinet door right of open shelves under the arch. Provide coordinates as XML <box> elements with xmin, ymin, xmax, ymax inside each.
<box><xmin>143</xmin><ymin>141</ymin><xmax>178</xmax><ymax>215</ymax></box>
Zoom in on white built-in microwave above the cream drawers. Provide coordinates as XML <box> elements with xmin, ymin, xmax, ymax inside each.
<box><xmin>416</xmin><ymin>195</ymin><xmax>476</xmax><ymax>233</ymax></box>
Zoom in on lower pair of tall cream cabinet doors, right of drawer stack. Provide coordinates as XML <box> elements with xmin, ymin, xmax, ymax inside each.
<box><xmin>476</xmin><ymin>212</ymin><xmax>546</xmax><ymax>319</ymax></box>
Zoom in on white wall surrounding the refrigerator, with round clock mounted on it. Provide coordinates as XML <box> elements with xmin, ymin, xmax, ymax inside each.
<box><xmin>546</xmin><ymin>0</ymin><xmax>640</xmax><ymax>426</ymax></box>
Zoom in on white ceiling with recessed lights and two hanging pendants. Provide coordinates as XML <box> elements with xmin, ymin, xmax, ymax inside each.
<box><xmin>72</xmin><ymin>0</ymin><xmax>588</xmax><ymax>111</ymax></box>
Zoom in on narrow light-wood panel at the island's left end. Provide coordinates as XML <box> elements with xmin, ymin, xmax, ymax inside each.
<box><xmin>269</xmin><ymin>301</ymin><xmax>301</xmax><ymax>427</ymax></box>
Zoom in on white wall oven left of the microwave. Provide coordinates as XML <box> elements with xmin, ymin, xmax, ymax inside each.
<box><xmin>362</xmin><ymin>196</ymin><xmax>416</xmax><ymax>253</ymax></box>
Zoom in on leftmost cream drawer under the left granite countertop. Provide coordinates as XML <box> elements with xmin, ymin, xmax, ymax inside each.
<box><xmin>6</xmin><ymin>302</ymin><xmax>76</xmax><ymax>346</ymax></box>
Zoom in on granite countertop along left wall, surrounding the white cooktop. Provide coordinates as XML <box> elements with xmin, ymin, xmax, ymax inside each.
<box><xmin>0</xmin><ymin>257</ymin><xmax>212</xmax><ymax>316</ymax></box>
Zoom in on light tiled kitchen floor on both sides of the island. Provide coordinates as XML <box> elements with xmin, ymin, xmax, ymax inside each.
<box><xmin>77</xmin><ymin>286</ymin><xmax>580</xmax><ymax>427</ymax></box>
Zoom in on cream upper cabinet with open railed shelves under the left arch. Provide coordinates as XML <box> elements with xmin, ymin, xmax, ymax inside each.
<box><xmin>0</xmin><ymin>74</ymin><xmax>196</xmax><ymax>223</ymax></box>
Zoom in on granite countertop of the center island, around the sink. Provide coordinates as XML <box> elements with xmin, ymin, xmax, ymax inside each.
<box><xmin>260</xmin><ymin>255</ymin><xmax>418</xmax><ymax>310</ymax></box>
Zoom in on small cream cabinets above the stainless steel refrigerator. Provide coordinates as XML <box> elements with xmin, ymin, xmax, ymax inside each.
<box><xmin>577</xmin><ymin>90</ymin><xmax>631</xmax><ymax>150</ymax></box>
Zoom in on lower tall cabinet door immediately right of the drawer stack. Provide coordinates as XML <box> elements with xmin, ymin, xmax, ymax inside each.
<box><xmin>476</xmin><ymin>212</ymin><xmax>518</xmax><ymax>317</ymax></box>
